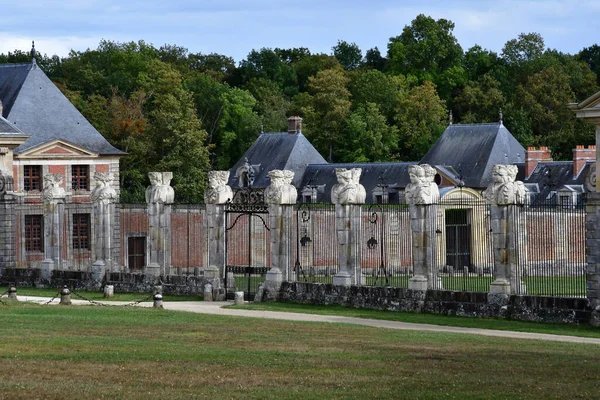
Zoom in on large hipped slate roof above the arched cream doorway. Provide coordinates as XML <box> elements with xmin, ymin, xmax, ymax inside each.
<box><xmin>420</xmin><ymin>123</ymin><xmax>525</xmax><ymax>188</ymax></box>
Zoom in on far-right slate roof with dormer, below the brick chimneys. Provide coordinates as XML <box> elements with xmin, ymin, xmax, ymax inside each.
<box><xmin>516</xmin><ymin>161</ymin><xmax>593</xmax><ymax>204</ymax></box>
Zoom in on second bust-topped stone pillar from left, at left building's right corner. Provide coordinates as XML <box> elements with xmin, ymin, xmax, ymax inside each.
<box><xmin>92</xmin><ymin>172</ymin><xmax>117</xmax><ymax>282</ymax></box>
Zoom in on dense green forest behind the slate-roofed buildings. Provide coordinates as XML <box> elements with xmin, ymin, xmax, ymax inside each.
<box><xmin>0</xmin><ymin>15</ymin><xmax>600</xmax><ymax>202</ymax></box>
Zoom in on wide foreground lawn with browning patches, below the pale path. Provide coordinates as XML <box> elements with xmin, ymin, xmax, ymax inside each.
<box><xmin>0</xmin><ymin>305</ymin><xmax>600</xmax><ymax>399</ymax></box>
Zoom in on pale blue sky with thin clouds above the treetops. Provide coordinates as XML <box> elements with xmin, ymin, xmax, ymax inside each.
<box><xmin>0</xmin><ymin>0</ymin><xmax>600</xmax><ymax>62</ymax></box>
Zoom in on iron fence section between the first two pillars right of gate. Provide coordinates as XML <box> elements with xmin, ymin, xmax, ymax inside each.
<box><xmin>291</xmin><ymin>204</ymin><xmax>339</xmax><ymax>283</ymax></box>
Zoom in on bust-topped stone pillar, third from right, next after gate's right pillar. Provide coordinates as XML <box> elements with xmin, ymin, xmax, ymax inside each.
<box><xmin>331</xmin><ymin>168</ymin><xmax>367</xmax><ymax>286</ymax></box>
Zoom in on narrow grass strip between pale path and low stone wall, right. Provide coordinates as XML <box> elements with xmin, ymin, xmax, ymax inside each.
<box><xmin>227</xmin><ymin>302</ymin><xmax>600</xmax><ymax>338</ymax></box>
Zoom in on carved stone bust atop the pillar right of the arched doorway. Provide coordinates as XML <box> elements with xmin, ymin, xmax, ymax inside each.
<box><xmin>483</xmin><ymin>164</ymin><xmax>527</xmax><ymax>206</ymax></box>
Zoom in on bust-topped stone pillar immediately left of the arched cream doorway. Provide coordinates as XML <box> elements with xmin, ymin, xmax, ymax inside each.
<box><xmin>405</xmin><ymin>164</ymin><xmax>441</xmax><ymax>290</ymax></box>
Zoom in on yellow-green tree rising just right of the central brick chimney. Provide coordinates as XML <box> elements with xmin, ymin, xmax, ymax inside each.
<box><xmin>302</xmin><ymin>67</ymin><xmax>351</xmax><ymax>162</ymax></box>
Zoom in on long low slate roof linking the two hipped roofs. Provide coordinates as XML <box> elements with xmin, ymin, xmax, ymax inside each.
<box><xmin>296</xmin><ymin>162</ymin><xmax>416</xmax><ymax>204</ymax></box>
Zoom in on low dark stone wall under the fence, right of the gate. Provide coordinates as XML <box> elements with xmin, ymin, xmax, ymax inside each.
<box><xmin>277</xmin><ymin>282</ymin><xmax>592</xmax><ymax>323</ymax></box>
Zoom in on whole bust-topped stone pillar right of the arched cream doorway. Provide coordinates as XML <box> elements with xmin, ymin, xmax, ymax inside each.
<box><xmin>483</xmin><ymin>165</ymin><xmax>525</xmax><ymax>295</ymax></box>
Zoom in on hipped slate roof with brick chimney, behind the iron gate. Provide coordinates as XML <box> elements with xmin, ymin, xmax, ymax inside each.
<box><xmin>229</xmin><ymin>132</ymin><xmax>327</xmax><ymax>190</ymax></box>
